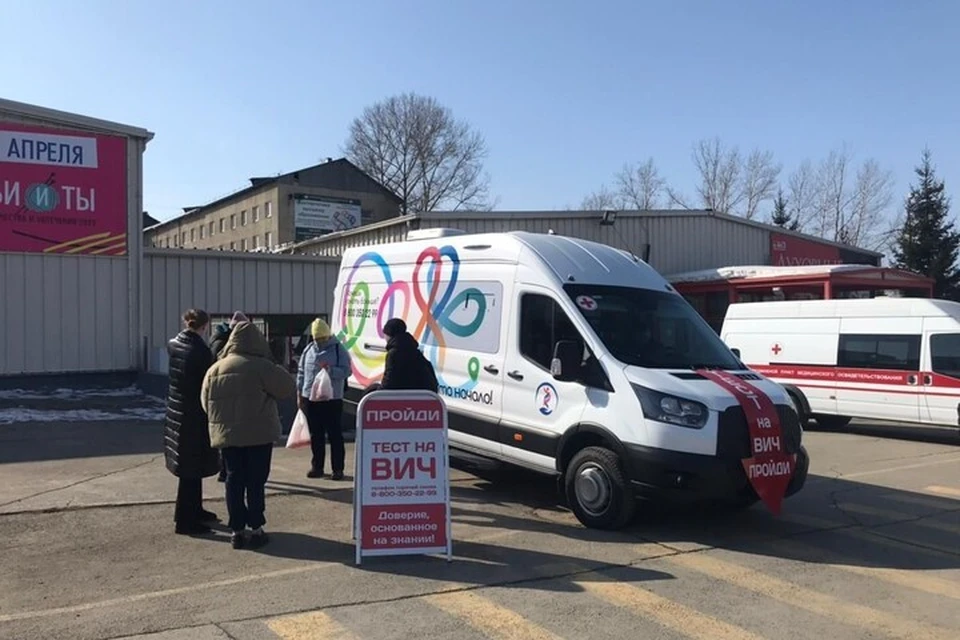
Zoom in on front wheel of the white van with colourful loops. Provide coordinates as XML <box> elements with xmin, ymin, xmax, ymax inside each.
<box><xmin>565</xmin><ymin>447</ymin><xmax>637</xmax><ymax>529</ymax></box>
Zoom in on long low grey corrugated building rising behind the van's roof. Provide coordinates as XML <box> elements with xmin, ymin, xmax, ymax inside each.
<box><xmin>287</xmin><ymin>210</ymin><xmax>882</xmax><ymax>275</ymax></box>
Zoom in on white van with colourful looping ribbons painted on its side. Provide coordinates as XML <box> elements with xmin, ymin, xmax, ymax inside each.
<box><xmin>331</xmin><ymin>230</ymin><xmax>808</xmax><ymax>528</ymax></box>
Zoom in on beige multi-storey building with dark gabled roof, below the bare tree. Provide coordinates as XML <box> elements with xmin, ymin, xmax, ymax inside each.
<box><xmin>144</xmin><ymin>158</ymin><xmax>403</xmax><ymax>251</ymax></box>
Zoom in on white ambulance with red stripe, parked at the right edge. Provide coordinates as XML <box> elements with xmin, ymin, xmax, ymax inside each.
<box><xmin>720</xmin><ymin>297</ymin><xmax>960</xmax><ymax>428</ymax></box>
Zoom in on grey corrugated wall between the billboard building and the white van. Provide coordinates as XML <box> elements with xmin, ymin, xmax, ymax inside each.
<box><xmin>143</xmin><ymin>248</ymin><xmax>340</xmax><ymax>353</ymax></box>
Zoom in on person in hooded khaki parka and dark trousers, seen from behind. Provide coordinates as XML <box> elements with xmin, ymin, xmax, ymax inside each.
<box><xmin>200</xmin><ymin>322</ymin><xmax>297</xmax><ymax>549</ymax></box>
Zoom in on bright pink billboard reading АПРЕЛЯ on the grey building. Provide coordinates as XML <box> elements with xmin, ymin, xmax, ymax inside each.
<box><xmin>0</xmin><ymin>122</ymin><xmax>127</xmax><ymax>256</ymax></box>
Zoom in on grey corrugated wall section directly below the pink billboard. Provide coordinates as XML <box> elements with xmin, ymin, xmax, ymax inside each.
<box><xmin>0</xmin><ymin>253</ymin><xmax>130</xmax><ymax>375</ymax></box>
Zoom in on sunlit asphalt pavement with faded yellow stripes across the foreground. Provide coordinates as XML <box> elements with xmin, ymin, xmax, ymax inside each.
<box><xmin>0</xmin><ymin>412</ymin><xmax>960</xmax><ymax>640</ymax></box>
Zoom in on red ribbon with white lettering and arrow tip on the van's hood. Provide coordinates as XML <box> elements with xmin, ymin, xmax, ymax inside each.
<box><xmin>698</xmin><ymin>371</ymin><xmax>797</xmax><ymax>515</ymax></box>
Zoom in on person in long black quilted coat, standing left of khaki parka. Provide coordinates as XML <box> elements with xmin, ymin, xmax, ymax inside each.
<box><xmin>164</xmin><ymin>309</ymin><xmax>220</xmax><ymax>535</ymax></box>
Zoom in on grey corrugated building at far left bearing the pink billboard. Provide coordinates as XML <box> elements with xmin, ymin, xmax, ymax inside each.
<box><xmin>0</xmin><ymin>99</ymin><xmax>153</xmax><ymax>375</ymax></box>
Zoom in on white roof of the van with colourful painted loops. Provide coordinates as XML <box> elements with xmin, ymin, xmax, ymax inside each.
<box><xmin>343</xmin><ymin>231</ymin><xmax>673</xmax><ymax>291</ymax></box>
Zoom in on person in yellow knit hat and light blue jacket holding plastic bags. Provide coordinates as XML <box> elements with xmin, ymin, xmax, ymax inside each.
<box><xmin>297</xmin><ymin>318</ymin><xmax>352</xmax><ymax>480</ymax></box>
